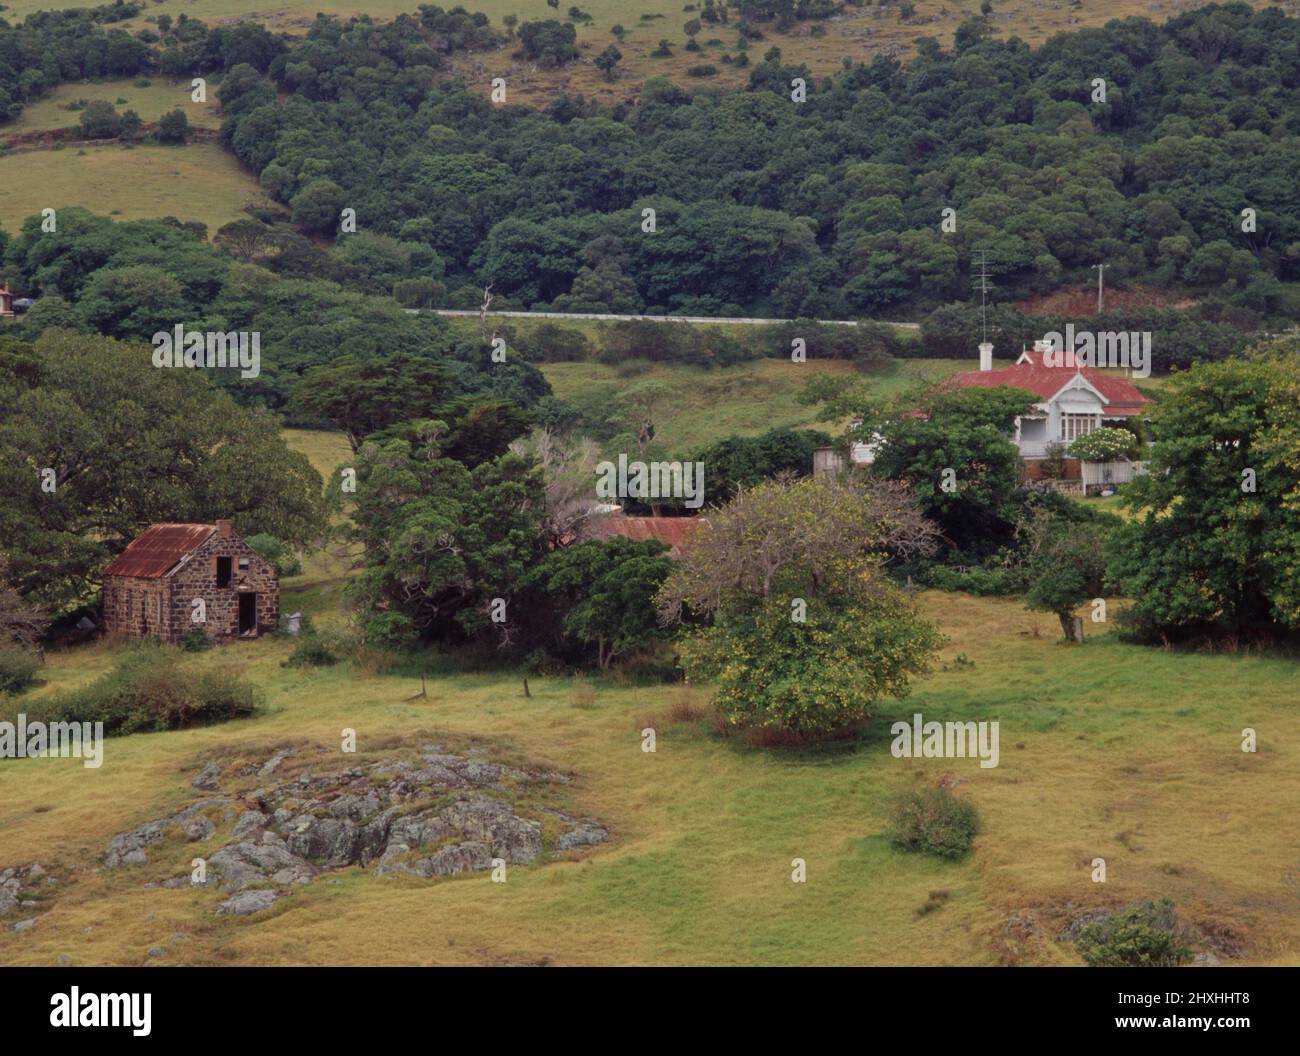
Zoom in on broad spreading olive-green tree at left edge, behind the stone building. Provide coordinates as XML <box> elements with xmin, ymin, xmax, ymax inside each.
<box><xmin>0</xmin><ymin>330</ymin><xmax>322</xmax><ymax>606</ymax></box>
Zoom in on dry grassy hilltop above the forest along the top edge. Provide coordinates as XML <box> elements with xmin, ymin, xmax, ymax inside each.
<box><xmin>5</xmin><ymin>0</ymin><xmax>1279</xmax><ymax>105</ymax></box>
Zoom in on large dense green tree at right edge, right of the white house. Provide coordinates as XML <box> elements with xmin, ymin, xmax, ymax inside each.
<box><xmin>1109</xmin><ymin>339</ymin><xmax>1300</xmax><ymax>639</ymax></box>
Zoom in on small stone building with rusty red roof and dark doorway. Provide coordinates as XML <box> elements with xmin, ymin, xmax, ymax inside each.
<box><xmin>104</xmin><ymin>520</ymin><xmax>280</xmax><ymax>642</ymax></box>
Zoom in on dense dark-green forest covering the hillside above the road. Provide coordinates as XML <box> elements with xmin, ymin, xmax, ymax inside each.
<box><xmin>0</xmin><ymin>4</ymin><xmax>1300</xmax><ymax>338</ymax></box>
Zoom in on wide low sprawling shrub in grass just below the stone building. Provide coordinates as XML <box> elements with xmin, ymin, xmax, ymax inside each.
<box><xmin>17</xmin><ymin>645</ymin><xmax>257</xmax><ymax>733</ymax></box>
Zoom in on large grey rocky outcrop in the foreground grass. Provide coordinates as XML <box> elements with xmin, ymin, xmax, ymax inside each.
<box><xmin>104</xmin><ymin>745</ymin><xmax>610</xmax><ymax>916</ymax></box>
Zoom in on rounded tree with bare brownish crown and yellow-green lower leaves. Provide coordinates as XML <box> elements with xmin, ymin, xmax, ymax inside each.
<box><xmin>659</xmin><ymin>479</ymin><xmax>940</xmax><ymax>736</ymax></box>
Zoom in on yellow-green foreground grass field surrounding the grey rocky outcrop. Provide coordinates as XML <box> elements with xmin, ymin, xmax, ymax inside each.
<box><xmin>0</xmin><ymin>582</ymin><xmax>1300</xmax><ymax>965</ymax></box>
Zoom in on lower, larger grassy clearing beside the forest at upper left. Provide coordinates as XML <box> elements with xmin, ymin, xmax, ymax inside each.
<box><xmin>0</xmin><ymin>143</ymin><xmax>263</xmax><ymax>237</ymax></box>
